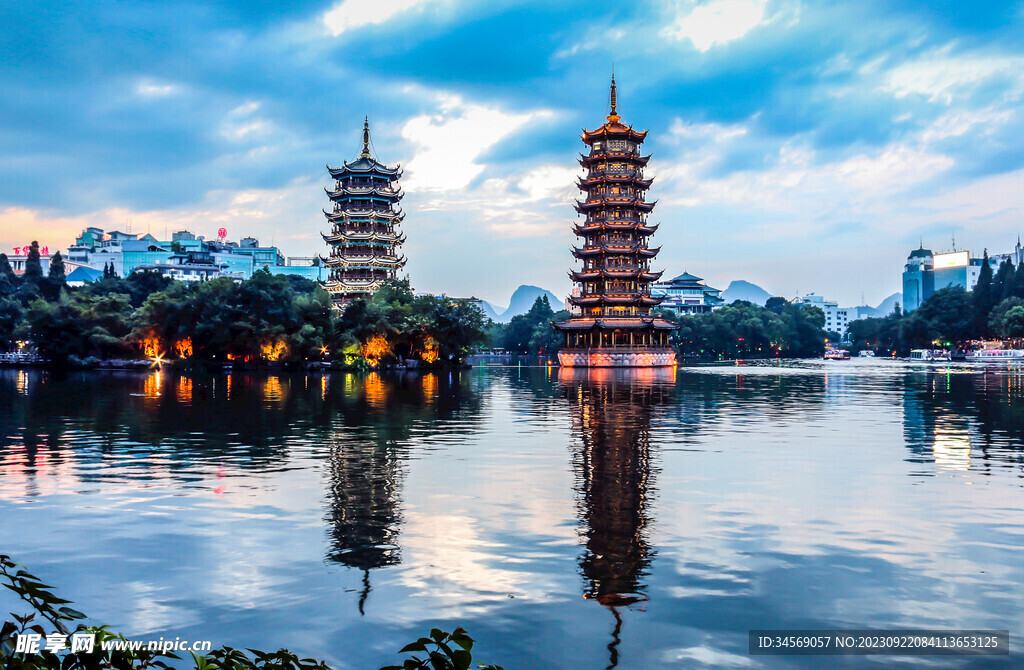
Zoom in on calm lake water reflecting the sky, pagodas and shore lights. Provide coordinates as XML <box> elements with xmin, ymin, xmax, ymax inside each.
<box><xmin>0</xmin><ymin>361</ymin><xmax>1024</xmax><ymax>670</ymax></box>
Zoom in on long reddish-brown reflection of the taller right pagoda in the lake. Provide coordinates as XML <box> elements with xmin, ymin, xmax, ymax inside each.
<box><xmin>558</xmin><ymin>368</ymin><xmax>675</xmax><ymax>668</ymax></box>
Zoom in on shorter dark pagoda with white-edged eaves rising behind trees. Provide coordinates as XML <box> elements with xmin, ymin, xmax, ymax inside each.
<box><xmin>321</xmin><ymin>121</ymin><xmax>407</xmax><ymax>307</ymax></box>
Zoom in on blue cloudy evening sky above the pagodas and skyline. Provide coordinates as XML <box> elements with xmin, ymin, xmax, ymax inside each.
<box><xmin>0</xmin><ymin>0</ymin><xmax>1024</xmax><ymax>305</ymax></box>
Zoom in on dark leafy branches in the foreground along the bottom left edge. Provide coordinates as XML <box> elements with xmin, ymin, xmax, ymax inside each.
<box><xmin>0</xmin><ymin>554</ymin><xmax>503</xmax><ymax>670</ymax></box>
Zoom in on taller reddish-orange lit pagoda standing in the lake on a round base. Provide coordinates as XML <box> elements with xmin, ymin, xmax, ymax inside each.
<box><xmin>554</xmin><ymin>77</ymin><xmax>677</xmax><ymax>367</ymax></box>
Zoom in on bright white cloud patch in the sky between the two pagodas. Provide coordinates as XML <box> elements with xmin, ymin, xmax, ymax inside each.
<box><xmin>401</xmin><ymin>96</ymin><xmax>552</xmax><ymax>193</ymax></box>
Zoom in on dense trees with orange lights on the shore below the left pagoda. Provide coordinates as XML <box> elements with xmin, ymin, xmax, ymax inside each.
<box><xmin>0</xmin><ymin>244</ymin><xmax>488</xmax><ymax>370</ymax></box>
